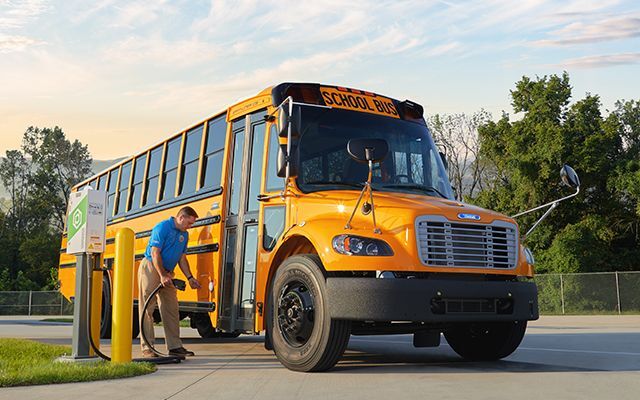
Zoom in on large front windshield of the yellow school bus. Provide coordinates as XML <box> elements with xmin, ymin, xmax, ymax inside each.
<box><xmin>297</xmin><ymin>106</ymin><xmax>453</xmax><ymax>199</ymax></box>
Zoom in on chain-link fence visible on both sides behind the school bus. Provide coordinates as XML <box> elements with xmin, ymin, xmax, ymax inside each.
<box><xmin>0</xmin><ymin>271</ymin><xmax>640</xmax><ymax>315</ymax></box>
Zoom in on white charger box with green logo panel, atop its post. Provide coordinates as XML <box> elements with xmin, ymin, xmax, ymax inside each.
<box><xmin>67</xmin><ymin>187</ymin><xmax>107</xmax><ymax>254</ymax></box>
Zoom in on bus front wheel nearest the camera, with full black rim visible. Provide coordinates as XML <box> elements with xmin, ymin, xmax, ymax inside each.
<box><xmin>269</xmin><ymin>254</ymin><xmax>351</xmax><ymax>372</ymax></box>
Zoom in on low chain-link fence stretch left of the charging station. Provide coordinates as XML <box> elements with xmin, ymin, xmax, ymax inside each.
<box><xmin>0</xmin><ymin>291</ymin><xmax>73</xmax><ymax>315</ymax></box>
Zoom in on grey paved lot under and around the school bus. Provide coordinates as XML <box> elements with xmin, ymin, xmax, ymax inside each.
<box><xmin>0</xmin><ymin>316</ymin><xmax>640</xmax><ymax>400</ymax></box>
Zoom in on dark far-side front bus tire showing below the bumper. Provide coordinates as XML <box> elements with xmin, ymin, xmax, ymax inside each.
<box><xmin>444</xmin><ymin>321</ymin><xmax>527</xmax><ymax>361</ymax></box>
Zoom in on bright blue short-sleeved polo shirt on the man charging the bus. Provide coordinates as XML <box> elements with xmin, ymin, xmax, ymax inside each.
<box><xmin>144</xmin><ymin>217</ymin><xmax>189</xmax><ymax>271</ymax></box>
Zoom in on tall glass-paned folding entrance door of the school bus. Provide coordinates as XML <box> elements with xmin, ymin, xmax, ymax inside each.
<box><xmin>218</xmin><ymin>111</ymin><xmax>266</xmax><ymax>332</ymax></box>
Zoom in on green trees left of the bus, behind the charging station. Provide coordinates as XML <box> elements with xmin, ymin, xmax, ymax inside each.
<box><xmin>0</xmin><ymin>127</ymin><xmax>91</xmax><ymax>290</ymax></box>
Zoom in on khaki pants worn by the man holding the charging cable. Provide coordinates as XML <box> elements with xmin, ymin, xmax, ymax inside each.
<box><xmin>138</xmin><ymin>258</ymin><xmax>182</xmax><ymax>351</ymax></box>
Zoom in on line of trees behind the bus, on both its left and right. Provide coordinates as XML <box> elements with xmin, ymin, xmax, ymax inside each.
<box><xmin>0</xmin><ymin>72</ymin><xmax>640</xmax><ymax>290</ymax></box>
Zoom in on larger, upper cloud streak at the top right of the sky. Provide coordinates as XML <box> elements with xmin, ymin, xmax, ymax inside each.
<box><xmin>533</xmin><ymin>15</ymin><xmax>640</xmax><ymax>46</ymax></box>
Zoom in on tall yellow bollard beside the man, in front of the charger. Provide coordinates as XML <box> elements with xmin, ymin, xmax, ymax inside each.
<box><xmin>111</xmin><ymin>228</ymin><xmax>135</xmax><ymax>363</ymax></box>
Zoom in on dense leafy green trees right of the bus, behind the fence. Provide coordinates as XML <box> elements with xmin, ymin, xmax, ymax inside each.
<box><xmin>476</xmin><ymin>72</ymin><xmax>640</xmax><ymax>272</ymax></box>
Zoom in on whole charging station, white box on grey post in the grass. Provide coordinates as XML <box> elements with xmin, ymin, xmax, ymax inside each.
<box><xmin>67</xmin><ymin>187</ymin><xmax>107</xmax><ymax>361</ymax></box>
